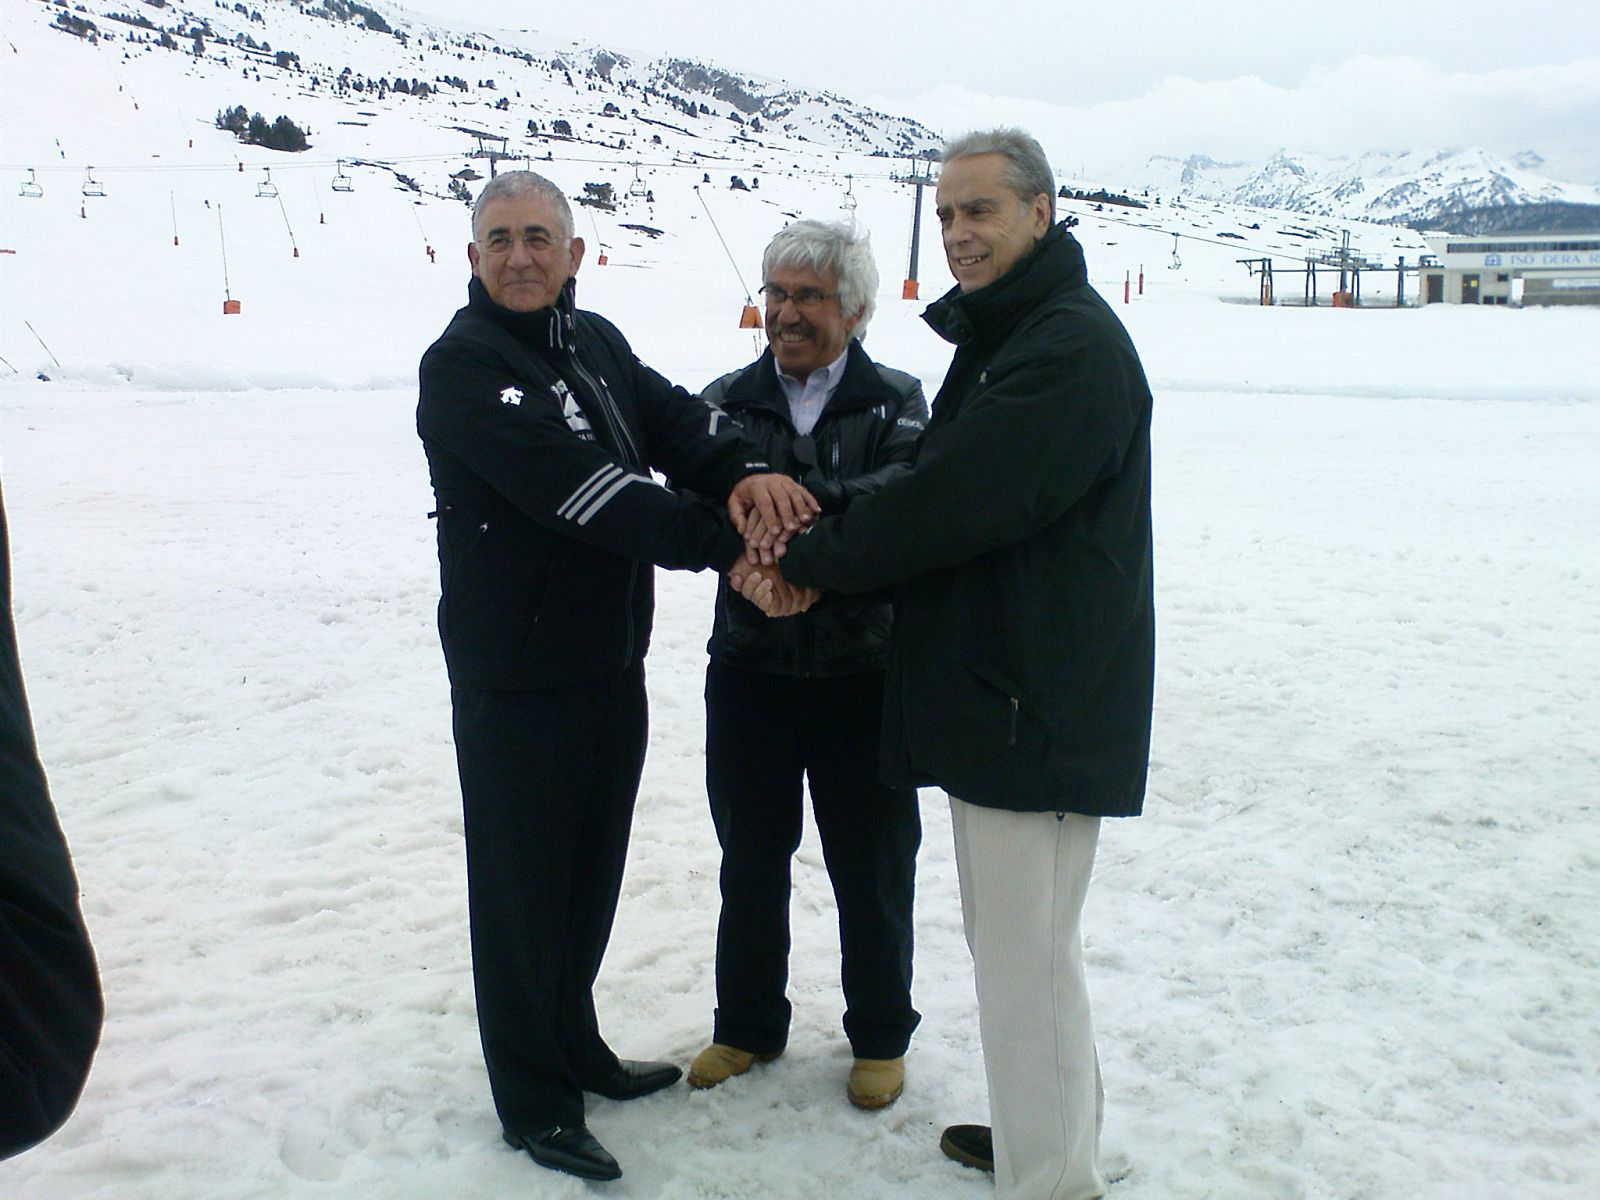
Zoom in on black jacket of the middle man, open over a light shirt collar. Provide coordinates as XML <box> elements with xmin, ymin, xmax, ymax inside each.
<box><xmin>702</xmin><ymin>338</ymin><xmax>928</xmax><ymax>675</ymax></box>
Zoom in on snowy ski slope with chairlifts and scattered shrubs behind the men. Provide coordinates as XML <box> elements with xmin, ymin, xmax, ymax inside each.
<box><xmin>0</xmin><ymin>0</ymin><xmax>1446</xmax><ymax>384</ymax></box>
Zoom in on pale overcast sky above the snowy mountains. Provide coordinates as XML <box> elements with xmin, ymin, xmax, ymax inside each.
<box><xmin>396</xmin><ymin>0</ymin><xmax>1600</xmax><ymax>182</ymax></box>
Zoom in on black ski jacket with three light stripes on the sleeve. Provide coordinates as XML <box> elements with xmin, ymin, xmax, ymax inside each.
<box><xmin>416</xmin><ymin>278</ymin><xmax>768</xmax><ymax>690</ymax></box>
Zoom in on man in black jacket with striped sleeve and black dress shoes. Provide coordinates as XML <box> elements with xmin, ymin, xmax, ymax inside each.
<box><xmin>416</xmin><ymin>171</ymin><xmax>816</xmax><ymax>1179</ymax></box>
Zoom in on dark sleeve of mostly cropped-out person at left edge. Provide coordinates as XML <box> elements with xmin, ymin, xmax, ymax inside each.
<box><xmin>0</xmin><ymin>483</ymin><xmax>104</xmax><ymax>1158</ymax></box>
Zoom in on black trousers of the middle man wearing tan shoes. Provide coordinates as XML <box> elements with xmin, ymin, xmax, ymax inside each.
<box><xmin>706</xmin><ymin>661</ymin><xmax>922</xmax><ymax>1058</ymax></box>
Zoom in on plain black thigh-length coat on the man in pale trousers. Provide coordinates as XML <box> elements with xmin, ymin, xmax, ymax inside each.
<box><xmin>784</xmin><ymin>226</ymin><xmax>1155</xmax><ymax>816</ymax></box>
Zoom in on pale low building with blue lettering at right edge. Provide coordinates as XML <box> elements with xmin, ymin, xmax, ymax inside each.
<box><xmin>1421</xmin><ymin>232</ymin><xmax>1600</xmax><ymax>306</ymax></box>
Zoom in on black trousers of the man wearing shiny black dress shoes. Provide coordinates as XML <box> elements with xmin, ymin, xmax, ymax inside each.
<box><xmin>451</xmin><ymin>666</ymin><xmax>646</xmax><ymax>1131</ymax></box>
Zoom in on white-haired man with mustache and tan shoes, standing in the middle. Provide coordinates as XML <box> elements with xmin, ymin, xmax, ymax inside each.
<box><xmin>688</xmin><ymin>221</ymin><xmax>928</xmax><ymax>1109</ymax></box>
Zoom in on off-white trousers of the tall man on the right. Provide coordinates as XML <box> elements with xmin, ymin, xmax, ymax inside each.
<box><xmin>950</xmin><ymin>795</ymin><xmax>1106</xmax><ymax>1200</ymax></box>
